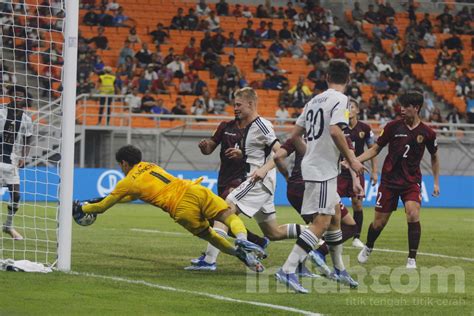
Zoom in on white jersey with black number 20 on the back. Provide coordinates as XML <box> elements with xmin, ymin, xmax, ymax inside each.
<box><xmin>296</xmin><ymin>89</ymin><xmax>349</xmax><ymax>181</ymax></box>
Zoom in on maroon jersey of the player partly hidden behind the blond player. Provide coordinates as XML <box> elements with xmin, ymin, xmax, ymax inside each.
<box><xmin>211</xmin><ymin>120</ymin><xmax>245</xmax><ymax>191</ymax></box>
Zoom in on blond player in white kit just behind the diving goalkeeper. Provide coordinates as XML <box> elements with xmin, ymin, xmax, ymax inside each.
<box><xmin>189</xmin><ymin>88</ymin><xmax>314</xmax><ymax>276</ymax></box>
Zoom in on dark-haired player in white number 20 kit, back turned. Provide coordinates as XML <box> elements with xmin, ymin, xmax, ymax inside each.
<box><xmin>275</xmin><ymin>59</ymin><xmax>364</xmax><ymax>293</ymax></box>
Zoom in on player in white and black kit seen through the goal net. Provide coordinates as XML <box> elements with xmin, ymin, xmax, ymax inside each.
<box><xmin>0</xmin><ymin>86</ymin><xmax>33</xmax><ymax>240</ymax></box>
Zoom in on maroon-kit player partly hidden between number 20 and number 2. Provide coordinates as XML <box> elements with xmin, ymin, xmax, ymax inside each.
<box><xmin>337</xmin><ymin>98</ymin><xmax>377</xmax><ymax>248</ymax></box>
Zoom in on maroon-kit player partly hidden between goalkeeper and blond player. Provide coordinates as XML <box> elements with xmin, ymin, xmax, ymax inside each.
<box><xmin>185</xmin><ymin>119</ymin><xmax>269</xmax><ymax>271</ymax></box>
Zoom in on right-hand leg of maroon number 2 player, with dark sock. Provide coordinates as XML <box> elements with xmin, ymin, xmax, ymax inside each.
<box><xmin>405</xmin><ymin>201</ymin><xmax>421</xmax><ymax>269</ymax></box>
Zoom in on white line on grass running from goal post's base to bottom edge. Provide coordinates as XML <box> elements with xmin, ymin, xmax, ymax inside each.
<box><xmin>69</xmin><ymin>272</ymin><xmax>322</xmax><ymax>316</ymax></box>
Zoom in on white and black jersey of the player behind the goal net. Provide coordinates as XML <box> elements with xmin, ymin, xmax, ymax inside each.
<box><xmin>0</xmin><ymin>104</ymin><xmax>33</xmax><ymax>165</ymax></box>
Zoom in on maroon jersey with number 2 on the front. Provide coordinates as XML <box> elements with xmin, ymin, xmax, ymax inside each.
<box><xmin>377</xmin><ymin>120</ymin><xmax>438</xmax><ymax>189</ymax></box>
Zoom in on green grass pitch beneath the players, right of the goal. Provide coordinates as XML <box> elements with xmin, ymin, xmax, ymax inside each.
<box><xmin>0</xmin><ymin>204</ymin><xmax>474</xmax><ymax>315</ymax></box>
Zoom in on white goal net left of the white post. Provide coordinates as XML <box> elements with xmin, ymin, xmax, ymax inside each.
<box><xmin>0</xmin><ymin>0</ymin><xmax>74</xmax><ymax>266</ymax></box>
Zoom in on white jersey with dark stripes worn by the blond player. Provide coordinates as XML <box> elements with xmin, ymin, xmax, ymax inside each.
<box><xmin>242</xmin><ymin>117</ymin><xmax>278</xmax><ymax>194</ymax></box>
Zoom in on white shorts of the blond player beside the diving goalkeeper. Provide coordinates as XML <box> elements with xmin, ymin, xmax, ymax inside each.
<box><xmin>227</xmin><ymin>179</ymin><xmax>275</xmax><ymax>222</ymax></box>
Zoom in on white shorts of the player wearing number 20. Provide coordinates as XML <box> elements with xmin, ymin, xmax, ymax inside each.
<box><xmin>301</xmin><ymin>177</ymin><xmax>341</xmax><ymax>215</ymax></box>
